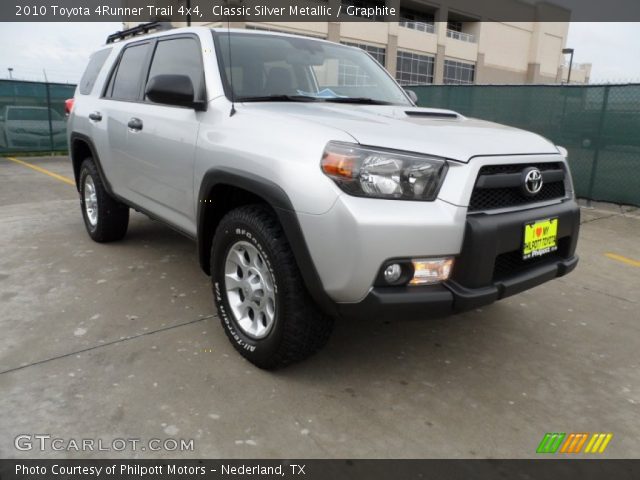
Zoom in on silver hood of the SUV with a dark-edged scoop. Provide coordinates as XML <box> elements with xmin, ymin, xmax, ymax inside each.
<box><xmin>244</xmin><ymin>102</ymin><xmax>559</xmax><ymax>162</ymax></box>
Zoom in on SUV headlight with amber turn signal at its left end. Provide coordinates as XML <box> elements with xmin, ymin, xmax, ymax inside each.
<box><xmin>321</xmin><ymin>142</ymin><xmax>447</xmax><ymax>201</ymax></box>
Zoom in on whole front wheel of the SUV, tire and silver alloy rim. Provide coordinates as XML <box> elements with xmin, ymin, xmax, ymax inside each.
<box><xmin>211</xmin><ymin>205</ymin><xmax>333</xmax><ymax>369</ymax></box>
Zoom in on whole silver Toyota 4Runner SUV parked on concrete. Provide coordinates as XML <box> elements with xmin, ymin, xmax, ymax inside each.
<box><xmin>68</xmin><ymin>26</ymin><xmax>580</xmax><ymax>369</ymax></box>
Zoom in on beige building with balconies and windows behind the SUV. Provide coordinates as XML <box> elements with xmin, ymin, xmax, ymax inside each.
<box><xmin>122</xmin><ymin>0</ymin><xmax>591</xmax><ymax>85</ymax></box>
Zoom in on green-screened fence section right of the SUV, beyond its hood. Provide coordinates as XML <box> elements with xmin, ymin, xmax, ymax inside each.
<box><xmin>408</xmin><ymin>85</ymin><xmax>640</xmax><ymax>206</ymax></box>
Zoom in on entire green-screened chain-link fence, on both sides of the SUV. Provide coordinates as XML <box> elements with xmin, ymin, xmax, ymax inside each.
<box><xmin>0</xmin><ymin>80</ymin><xmax>640</xmax><ymax>206</ymax></box>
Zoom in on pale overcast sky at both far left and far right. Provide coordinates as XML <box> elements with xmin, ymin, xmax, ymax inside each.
<box><xmin>0</xmin><ymin>22</ymin><xmax>640</xmax><ymax>83</ymax></box>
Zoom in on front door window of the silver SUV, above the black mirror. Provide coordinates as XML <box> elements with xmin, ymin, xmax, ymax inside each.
<box><xmin>149</xmin><ymin>38</ymin><xmax>204</xmax><ymax>100</ymax></box>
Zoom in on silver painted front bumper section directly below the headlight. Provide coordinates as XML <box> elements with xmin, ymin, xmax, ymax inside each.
<box><xmin>297</xmin><ymin>195</ymin><xmax>467</xmax><ymax>303</ymax></box>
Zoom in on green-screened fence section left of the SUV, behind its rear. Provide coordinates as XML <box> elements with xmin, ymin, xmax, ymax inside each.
<box><xmin>0</xmin><ymin>80</ymin><xmax>76</xmax><ymax>155</ymax></box>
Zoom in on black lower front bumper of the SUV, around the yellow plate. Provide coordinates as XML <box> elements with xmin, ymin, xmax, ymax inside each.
<box><xmin>338</xmin><ymin>200</ymin><xmax>580</xmax><ymax>318</ymax></box>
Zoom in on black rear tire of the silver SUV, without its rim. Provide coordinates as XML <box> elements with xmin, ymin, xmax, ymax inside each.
<box><xmin>79</xmin><ymin>157</ymin><xmax>129</xmax><ymax>243</ymax></box>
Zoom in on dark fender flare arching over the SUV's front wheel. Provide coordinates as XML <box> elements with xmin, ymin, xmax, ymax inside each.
<box><xmin>197</xmin><ymin>167</ymin><xmax>337</xmax><ymax>315</ymax></box>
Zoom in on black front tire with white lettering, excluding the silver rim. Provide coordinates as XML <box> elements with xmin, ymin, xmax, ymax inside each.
<box><xmin>211</xmin><ymin>205</ymin><xmax>333</xmax><ymax>370</ymax></box>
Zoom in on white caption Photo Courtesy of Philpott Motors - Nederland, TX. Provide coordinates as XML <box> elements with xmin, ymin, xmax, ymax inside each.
<box><xmin>15</xmin><ymin>463</ymin><xmax>306</xmax><ymax>477</ymax></box>
